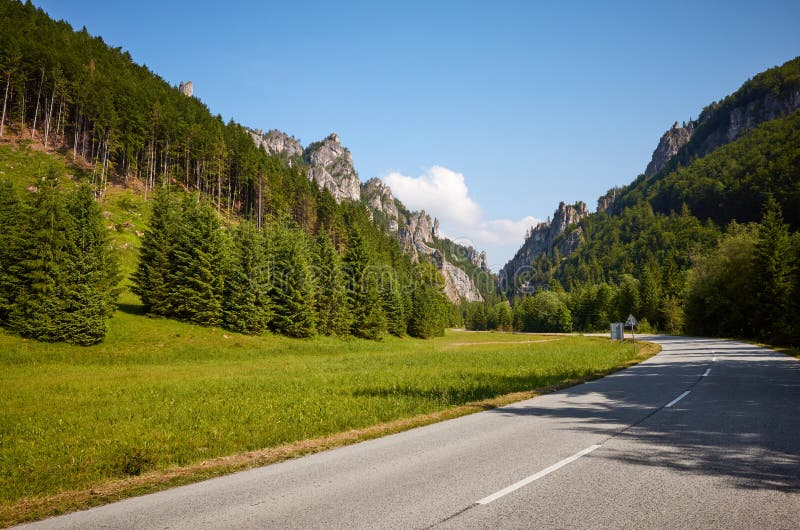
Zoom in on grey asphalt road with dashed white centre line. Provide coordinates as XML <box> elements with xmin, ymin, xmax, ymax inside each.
<box><xmin>21</xmin><ymin>337</ymin><xmax>800</xmax><ymax>529</ymax></box>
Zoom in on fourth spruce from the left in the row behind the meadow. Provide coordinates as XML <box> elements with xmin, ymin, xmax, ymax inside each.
<box><xmin>270</xmin><ymin>226</ymin><xmax>316</xmax><ymax>337</ymax></box>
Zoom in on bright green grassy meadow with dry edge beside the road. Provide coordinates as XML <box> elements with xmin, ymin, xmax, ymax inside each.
<box><xmin>0</xmin><ymin>314</ymin><xmax>656</xmax><ymax>525</ymax></box>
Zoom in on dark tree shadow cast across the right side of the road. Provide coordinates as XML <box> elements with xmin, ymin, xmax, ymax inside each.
<box><xmin>484</xmin><ymin>338</ymin><xmax>800</xmax><ymax>492</ymax></box>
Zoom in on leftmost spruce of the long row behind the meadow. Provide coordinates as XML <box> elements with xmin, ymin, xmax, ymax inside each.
<box><xmin>131</xmin><ymin>188</ymin><xmax>181</xmax><ymax>316</ymax></box>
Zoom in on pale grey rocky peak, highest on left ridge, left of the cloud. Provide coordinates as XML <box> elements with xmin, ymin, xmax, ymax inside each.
<box><xmin>303</xmin><ymin>133</ymin><xmax>361</xmax><ymax>202</ymax></box>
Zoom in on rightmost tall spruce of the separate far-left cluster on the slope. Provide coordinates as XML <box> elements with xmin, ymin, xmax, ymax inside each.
<box><xmin>56</xmin><ymin>185</ymin><xmax>119</xmax><ymax>345</ymax></box>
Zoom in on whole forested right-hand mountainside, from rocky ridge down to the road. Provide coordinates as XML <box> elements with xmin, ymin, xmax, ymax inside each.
<box><xmin>500</xmin><ymin>58</ymin><xmax>800</xmax><ymax>342</ymax></box>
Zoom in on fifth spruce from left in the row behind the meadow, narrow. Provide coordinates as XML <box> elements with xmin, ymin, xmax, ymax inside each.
<box><xmin>314</xmin><ymin>233</ymin><xmax>350</xmax><ymax>335</ymax></box>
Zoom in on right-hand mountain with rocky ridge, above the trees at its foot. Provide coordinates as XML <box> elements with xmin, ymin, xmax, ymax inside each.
<box><xmin>501</xmin><ymin>58</ymin><xmax>800</xmax><ymax>294</ymax></box>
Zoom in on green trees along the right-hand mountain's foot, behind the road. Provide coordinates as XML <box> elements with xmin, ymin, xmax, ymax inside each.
<box><xmin>472</xmin><ymin>199</ymin><xmax>800</xmax><ymax>344</ymax></box>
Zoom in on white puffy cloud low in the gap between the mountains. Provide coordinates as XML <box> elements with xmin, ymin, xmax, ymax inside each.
<box><xmin>383</xmin><ymin>166</ymin><xmax>540</xmax><ymax>259</ymax></box>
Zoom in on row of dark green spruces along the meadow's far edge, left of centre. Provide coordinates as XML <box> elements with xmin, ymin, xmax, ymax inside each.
<box><xmin>132</xmin><ymin>188</ymin><xmax>449</xmax><ymax>339</ymax></box>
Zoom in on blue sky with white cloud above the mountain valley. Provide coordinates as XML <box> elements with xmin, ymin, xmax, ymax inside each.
<box><xmin>29</xmin><ymin>0</ymin><xmax>800</xmax><ymax>267</ymax></box>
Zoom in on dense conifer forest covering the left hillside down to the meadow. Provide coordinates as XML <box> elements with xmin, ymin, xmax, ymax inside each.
<box><xmin>0</xmin><ymin>0</ymin><xmax>453</xmax><ymax>344</ymax></box>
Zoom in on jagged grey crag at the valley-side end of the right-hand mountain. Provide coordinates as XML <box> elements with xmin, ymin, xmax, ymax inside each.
<box><xmin>500</xmin><ymin>202</ymin><xmax>589</xmax><ymax>290</ymax></box>
